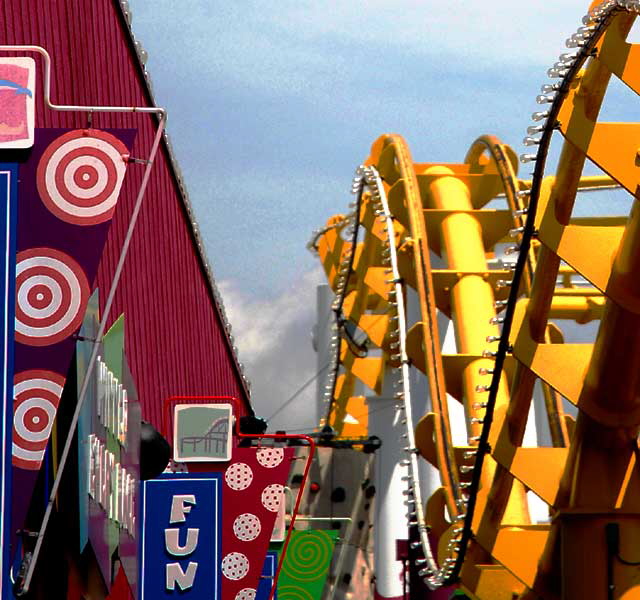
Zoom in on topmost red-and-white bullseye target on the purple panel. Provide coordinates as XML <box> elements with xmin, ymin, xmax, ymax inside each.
<box><xmin>36</xmin><ymin>129</ymin><xmax>129</xmax><ymax>225</ymax></box>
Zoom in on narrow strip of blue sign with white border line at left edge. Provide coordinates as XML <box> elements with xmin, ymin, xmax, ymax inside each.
<box><xmin>0</xmin><ymin>163</ymin><xmax>18</xmax><ymax>600</ymax></box>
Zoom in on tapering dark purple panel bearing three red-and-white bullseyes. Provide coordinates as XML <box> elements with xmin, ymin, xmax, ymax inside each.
<box><xmin>11</xmin><ymin>127</ymin><xmax>135</xmax><ymax>552</ymax></box>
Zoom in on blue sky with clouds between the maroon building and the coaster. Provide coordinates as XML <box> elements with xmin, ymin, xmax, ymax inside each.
<box><xmin>129</xmin><ymin>0</ymin><xmax>612</xmax><ymax>431</ymax></box>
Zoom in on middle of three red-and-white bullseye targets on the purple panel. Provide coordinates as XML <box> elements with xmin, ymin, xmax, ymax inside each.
<box><xmin>16</xmin><ymin>248</ymin><xmax>91</xmax><ymax>346</ymax></box>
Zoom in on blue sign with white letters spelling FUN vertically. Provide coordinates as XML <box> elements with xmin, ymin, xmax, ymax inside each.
<box><xmin>138</xmin><ymin>473</ymin><xmax>222</xmax><ymax>600</ymax></box>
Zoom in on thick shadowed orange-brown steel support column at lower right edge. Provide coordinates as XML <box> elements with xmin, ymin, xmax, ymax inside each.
<box><xmin>558</xmin><ymin>200</ymin><xmax>640</xmax><ymax>600</ymax></box>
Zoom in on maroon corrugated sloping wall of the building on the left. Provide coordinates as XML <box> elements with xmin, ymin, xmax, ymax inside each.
<box><xmin>0</xmin><ymin>0</ymin><xmax>248</xmax><ymax>427</ymax></box>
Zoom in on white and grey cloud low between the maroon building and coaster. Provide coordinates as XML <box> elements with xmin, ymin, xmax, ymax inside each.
<box><xmin>218</xmin><ymin>268</ymin><xmax>324</xmax><ymax>431</ymax></box>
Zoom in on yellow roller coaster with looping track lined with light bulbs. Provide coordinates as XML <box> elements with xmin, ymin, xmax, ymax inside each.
<box><xmin>310</xmin><ymin>0</ymin><xmax>640</xmax><ymax>600</ymax></box>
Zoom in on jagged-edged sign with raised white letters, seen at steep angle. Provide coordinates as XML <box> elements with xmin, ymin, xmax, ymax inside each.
<box><xmin>76</xmin><ymin>312</ymin><xmax>140</xmax><ymax>588</ymax></box>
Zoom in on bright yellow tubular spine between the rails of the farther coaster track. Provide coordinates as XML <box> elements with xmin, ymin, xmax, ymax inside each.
<box><xmin>424</xmin><ymin>166</ymin><xmax>529</xmax><ymax>524</ymax></box>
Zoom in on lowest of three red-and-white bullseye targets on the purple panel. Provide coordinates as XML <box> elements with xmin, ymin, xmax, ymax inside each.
<box><xmin>12</xmin><ymin>369</ymin><xmax>65</xmax><ymax>471</ymax></box>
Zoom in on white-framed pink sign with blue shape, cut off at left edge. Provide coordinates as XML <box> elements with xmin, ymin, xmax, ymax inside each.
<box><xmin>0</xmin><ymin>56</ymin><xmax>36</xmax><ymax>149</ymax></box>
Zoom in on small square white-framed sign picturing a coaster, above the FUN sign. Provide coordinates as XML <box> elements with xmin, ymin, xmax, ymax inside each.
<box><xmin>173</xmin><ymin>404</ymin><xmax>232</xmax><ymax>462</ymax></box>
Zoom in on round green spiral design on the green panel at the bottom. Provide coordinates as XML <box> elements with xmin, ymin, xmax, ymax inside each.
<box><xmin>282</xmin><ymin>531</ymin><xmax>334</xmax><ymax>581</ymax></box>
